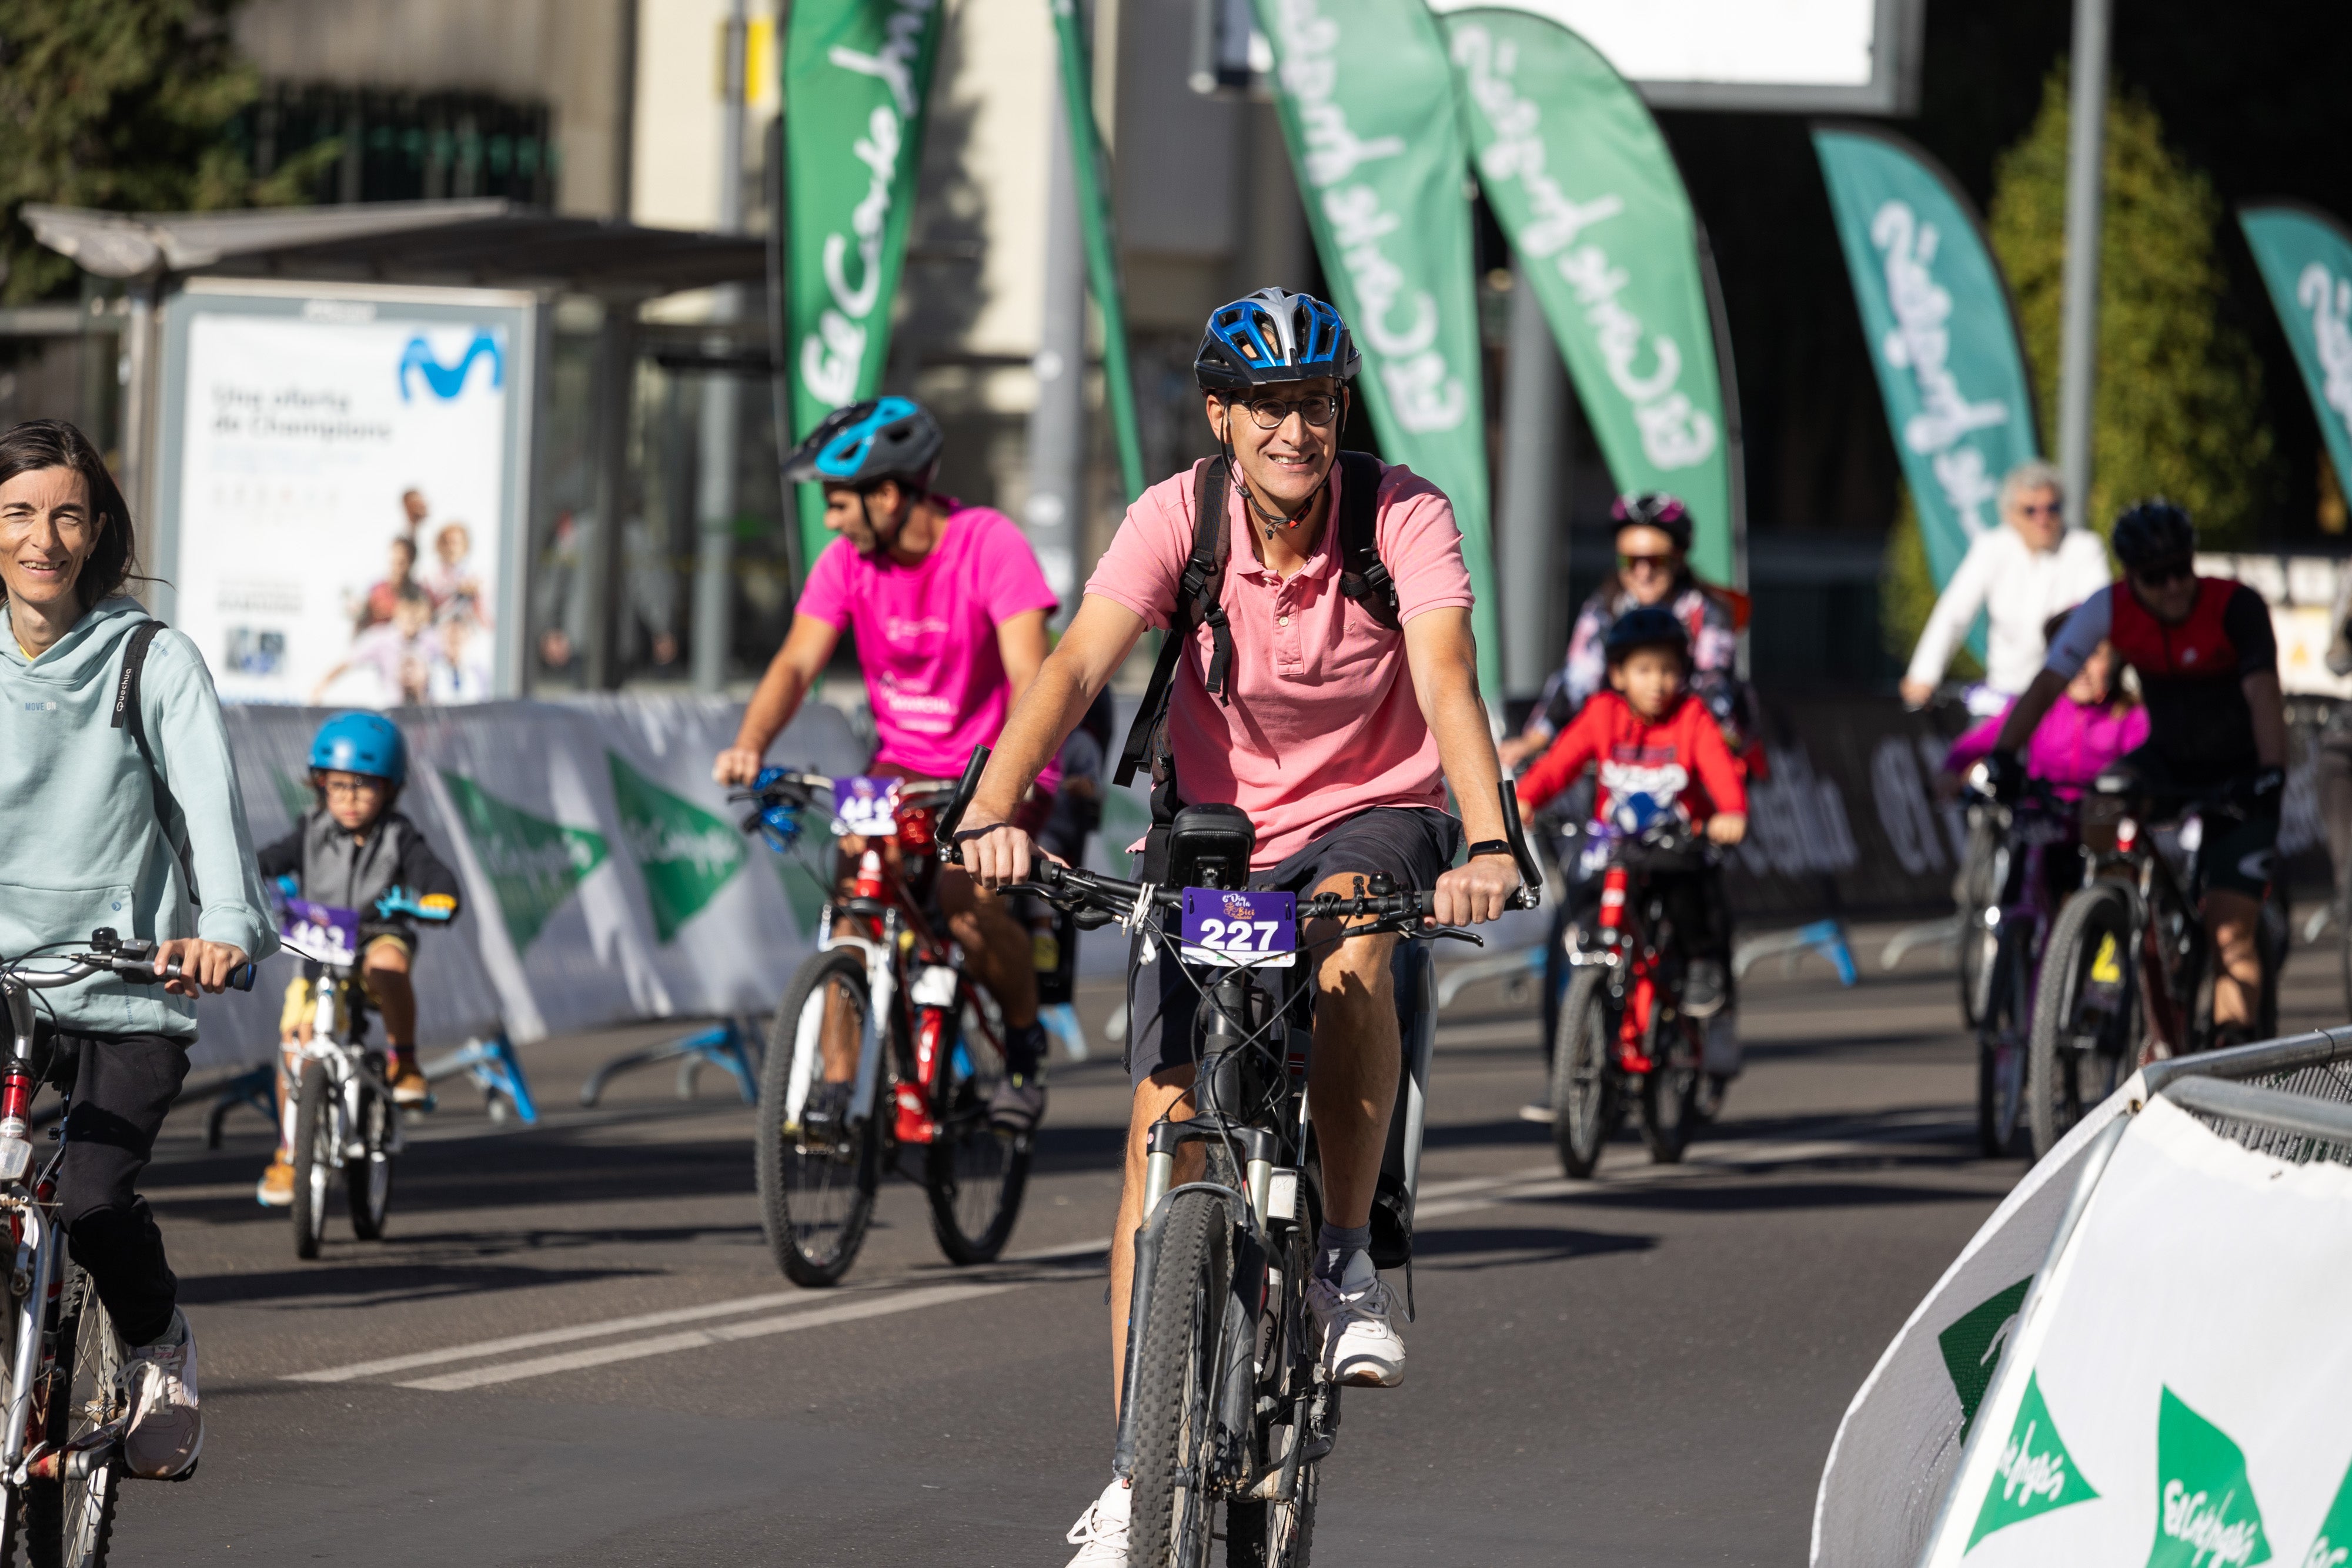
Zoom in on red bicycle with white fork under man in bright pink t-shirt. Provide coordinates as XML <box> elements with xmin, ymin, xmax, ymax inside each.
<box><xmin>734</xmin><ymin>769</ymin><xmax>1030</xmax><ymax>1286</ymax></box>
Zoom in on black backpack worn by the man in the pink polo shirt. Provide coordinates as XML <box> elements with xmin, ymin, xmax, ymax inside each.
<box><xmin>1112</xmin><ymin>452</ymin><xmax>1402</xmax><ymax>851</ymax></box>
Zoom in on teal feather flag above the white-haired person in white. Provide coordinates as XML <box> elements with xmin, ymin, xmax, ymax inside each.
<box><xmin>1813</xmin><ymin>129</ymin><xmax>2039</xmax><ymax>601</ymax></box>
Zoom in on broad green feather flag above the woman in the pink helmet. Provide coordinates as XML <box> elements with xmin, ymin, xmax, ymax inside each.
<box><xmin>1432</xmin><ymin>0</ymin><xmax>1738</xmax><ymax>583</ymax></box>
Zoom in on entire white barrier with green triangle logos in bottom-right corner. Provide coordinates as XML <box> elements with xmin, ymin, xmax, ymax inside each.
<box><xmin>1811</xmin><ymin>1062</ymin><xmax>2352</xmax><ymax>1568</ymax></box>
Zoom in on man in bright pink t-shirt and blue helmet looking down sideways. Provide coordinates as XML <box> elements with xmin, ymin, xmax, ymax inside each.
<box><xmin>710</xmin><ymin>397</ymin><xmax>1054</xmax><ymax>1133</ymax></box>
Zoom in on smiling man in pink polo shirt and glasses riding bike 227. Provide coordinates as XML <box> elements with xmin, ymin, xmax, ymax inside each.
<box><xmin>957</xmin><ymin>289</ymin><xmax>1519</xmax><ymax>1568</ymax></box>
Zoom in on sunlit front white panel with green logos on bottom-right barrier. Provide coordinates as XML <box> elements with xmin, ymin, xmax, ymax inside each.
<box><xmin>1929</xmin><ymin>1100</ymin><xmax>2352</xmax><ymax>1568</ymax></box>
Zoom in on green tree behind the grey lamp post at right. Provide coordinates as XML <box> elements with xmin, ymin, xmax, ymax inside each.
<box><xmin>1990</xmin><ymin>63</ymin><xmax>2272</xmax><ymax>543</ymax></box>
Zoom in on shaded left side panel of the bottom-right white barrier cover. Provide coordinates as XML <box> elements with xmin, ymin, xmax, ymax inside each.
<box><xmin>1811</xmin><ymin>1074</ymin><xmax>2145</xmax><ymax>1568</ymax></box>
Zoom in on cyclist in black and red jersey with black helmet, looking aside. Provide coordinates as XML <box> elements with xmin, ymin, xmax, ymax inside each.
<box><xmin>1985</xmin><ymin>501</ymin><xmax>2286</xmax><ymax>1039</ymax></box>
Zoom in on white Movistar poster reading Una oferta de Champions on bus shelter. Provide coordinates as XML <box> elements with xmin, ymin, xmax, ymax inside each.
<box><xmin>153</xmin><ymin>280</ymin><xmax>536</xmax><ymax>708</ymax></box>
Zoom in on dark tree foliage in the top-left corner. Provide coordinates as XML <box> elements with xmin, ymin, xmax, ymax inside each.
<box><xmin>0</xmin><ymin>0</ymin><xmax>339</xmax><ymax>303</ymax></box>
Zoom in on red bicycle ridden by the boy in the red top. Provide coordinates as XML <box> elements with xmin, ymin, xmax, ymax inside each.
<box><xmin>1552</xmin><ymin>813</ymin><xmax>1708</xmax><ymax>1178</ymax></box>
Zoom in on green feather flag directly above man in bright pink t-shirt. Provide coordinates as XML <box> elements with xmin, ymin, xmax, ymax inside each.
<box><xmin>783</xmin><ymin>0</ymin><xmax>946</xmax><ymax>569</ymax></box>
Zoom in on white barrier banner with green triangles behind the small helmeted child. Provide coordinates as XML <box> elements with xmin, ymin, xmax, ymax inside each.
<box><xmin>193</xmin><ymin>696</ymin><xmax>866</xmax><ymax>1081</ymax></box>
